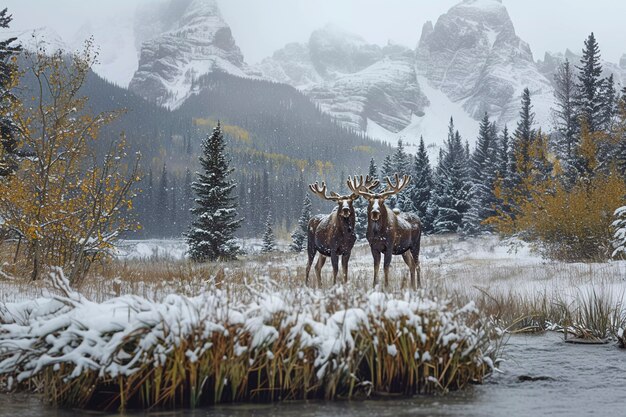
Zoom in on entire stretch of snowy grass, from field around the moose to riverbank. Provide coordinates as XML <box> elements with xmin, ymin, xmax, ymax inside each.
<box><xmin>0</xmin><ymin>236</ymin><xmax>626</xmax><ymax>407</ymax></box>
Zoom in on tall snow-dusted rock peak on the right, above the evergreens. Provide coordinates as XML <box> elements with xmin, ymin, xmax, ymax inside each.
<box><xmin>415</xmin><ymin>0</ymin><xmax>552</xmax><ymax>124</ymax></box>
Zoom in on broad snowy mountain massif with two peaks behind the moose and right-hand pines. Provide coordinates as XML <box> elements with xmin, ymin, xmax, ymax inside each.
<box><xmin>258</xmin><ymin>0</ymin><xmax>552</xmax><ymax>150</ymax></box>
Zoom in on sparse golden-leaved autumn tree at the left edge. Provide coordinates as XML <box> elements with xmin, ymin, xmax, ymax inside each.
<box><xmin>0</xmin><ymin>43</ymin><xmax>138</xmax><ymax>283</ymax></box>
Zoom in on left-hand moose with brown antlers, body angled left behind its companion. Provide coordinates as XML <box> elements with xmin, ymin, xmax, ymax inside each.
<box><xmin>305</xmin><ymin>175</ymin><xmax>379</xmax><ymax>287</ymax></box>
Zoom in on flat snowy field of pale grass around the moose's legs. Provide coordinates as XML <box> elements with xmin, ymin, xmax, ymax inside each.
<box><xmin>0</xmin><ymin>235</ymin><xmax>626</xmax><ymax>304</ymax></box>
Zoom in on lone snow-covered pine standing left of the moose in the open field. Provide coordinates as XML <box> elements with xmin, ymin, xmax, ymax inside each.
<box><xmin>185</xmin><ymin>122</ymin><xmax>242</xmax><ymax>262</ymax></box>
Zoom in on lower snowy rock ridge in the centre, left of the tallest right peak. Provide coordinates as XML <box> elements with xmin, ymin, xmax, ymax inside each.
<box><xmin>258</xmin><ymin>25</ymin><xmax>428</xmax><ymax>132</ymax></box>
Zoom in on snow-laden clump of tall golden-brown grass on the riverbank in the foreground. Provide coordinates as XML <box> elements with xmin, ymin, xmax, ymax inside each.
<box><xmin>0</xmin><ymin>271</ymin><xmax>496</xmax><ymax>410</ymax></box>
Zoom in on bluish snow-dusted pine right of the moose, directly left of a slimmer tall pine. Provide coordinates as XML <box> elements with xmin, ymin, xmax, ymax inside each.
<box><xmin>429</xmin><ymin>118</ymin><xmax>470</xmax><ymax>234</ymax></box>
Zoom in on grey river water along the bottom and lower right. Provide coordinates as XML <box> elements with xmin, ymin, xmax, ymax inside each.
<box><xmin>0</xmin><ymin>333</ymin><xmax>626</xmax><ymax>417</ymax></box>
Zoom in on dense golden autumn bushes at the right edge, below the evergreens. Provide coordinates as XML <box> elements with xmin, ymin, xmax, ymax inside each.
<box><xmin>487</xmin><ymin>124</ymin><xmax>626</xmax><ymax>261</ymax></box>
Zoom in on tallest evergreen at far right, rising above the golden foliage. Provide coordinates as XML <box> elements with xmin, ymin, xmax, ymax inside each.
<box><xmin>575</xmin><ymin>32</ymin><xmax>603</xmax><ymax>132</ymax></box>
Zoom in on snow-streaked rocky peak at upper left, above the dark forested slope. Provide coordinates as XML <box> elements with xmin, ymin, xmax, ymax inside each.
<box><xmin>129</xmin><ymin>0</ymin><xmax>247</xmax><ymax>108</ymax></box>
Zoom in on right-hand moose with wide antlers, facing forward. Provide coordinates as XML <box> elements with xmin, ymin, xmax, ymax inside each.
<box><xmin>348</xmin><ymin>174</ymin><xmax>422</xmax><ymax>288</ymax></box>
